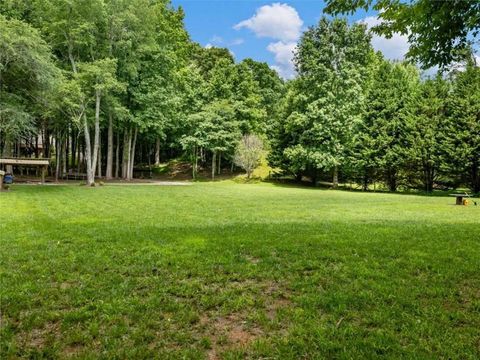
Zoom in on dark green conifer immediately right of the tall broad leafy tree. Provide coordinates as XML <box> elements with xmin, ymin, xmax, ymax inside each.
<box><xmin>352</xmin><ymin>60</ymin><xmax>420</xmax><ymax>191</ymax></box>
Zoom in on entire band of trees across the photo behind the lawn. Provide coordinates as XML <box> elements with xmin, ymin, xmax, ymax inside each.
<box><xmin>0</xmin><ymin>0</ymin><xmax>480</xmax><ymax>192</ymax></box>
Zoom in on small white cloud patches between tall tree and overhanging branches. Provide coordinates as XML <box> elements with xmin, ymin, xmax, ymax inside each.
<box><xmin>359</xmin><ymin>16</ymin><xmax>409</xmax><ymax>60</ymax></box>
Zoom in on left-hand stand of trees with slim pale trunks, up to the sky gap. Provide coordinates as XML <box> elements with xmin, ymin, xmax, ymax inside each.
<box><xmin>0</xmin><ymin>0</ymin><xmax>283</xmax><ymax>184</ymax></box>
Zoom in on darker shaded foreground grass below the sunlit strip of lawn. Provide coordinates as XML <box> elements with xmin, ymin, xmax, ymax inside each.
<box><xmin>0</xmin><ymin>218</ymin><xmax>480</xmax><ymax>358</ymax></box>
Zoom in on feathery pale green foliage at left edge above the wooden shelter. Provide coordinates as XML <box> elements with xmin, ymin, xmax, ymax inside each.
<box><xmin>0</xmin><ymin>15</ymin><xmax>60</xmax><ymax>148</ymax></box>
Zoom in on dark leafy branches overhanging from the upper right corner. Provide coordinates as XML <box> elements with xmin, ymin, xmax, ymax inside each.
<box><xmin>325</xmin><ymin>0</ymin><xmax>480</xmax><ymax>68</ymax></box>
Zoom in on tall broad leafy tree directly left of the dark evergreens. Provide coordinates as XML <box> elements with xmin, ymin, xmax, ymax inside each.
<box><xmin>285</xmin><ymin>18</ymin><xmax>373</xmax><ymax>188</ymax></box>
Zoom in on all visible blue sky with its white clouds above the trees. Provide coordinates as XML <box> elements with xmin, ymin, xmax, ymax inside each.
<box><xmin>172</xmin><ymin>0</ymin><xmax>408</xmax><ymax>78</ymax></box>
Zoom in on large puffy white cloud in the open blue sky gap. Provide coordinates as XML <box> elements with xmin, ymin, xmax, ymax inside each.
<box><xmin>234</xmin><ymin>3</ymin><xmax>303</xmax><ymax>42</ymax></box>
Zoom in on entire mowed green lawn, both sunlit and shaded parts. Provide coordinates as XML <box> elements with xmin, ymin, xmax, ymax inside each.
<box><xmin>0</xmin><ymin>182</ymin><xmax>480</xmax><ymax>359</ymax></box>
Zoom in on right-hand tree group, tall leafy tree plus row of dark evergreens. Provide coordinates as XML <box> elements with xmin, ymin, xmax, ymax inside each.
<box><xmin>270</xmin><ymin>19</ymin><xmax>480</xmax><ymax>192</ymax></box>
